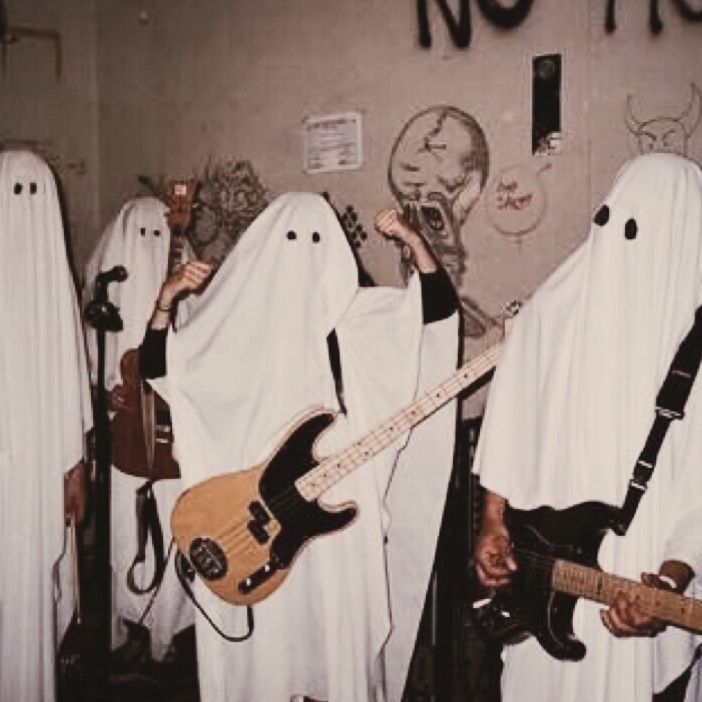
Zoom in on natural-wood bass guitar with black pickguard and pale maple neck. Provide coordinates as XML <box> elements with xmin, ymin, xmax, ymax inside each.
<box><xmin>171</xmin><ymin>332</ymin><xmax>502</xmax><ymax>605</ymax></box>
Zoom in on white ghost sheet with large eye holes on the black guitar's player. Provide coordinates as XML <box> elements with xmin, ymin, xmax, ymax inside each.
<box><xmin>474</xmin><ymin>154</ymin><xmax>702</xmax><ymax>702</ymax></box>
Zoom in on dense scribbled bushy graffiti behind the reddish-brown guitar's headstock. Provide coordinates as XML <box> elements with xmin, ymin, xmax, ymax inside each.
<box><xmin>139</xmin><ymin>159</ymin><xmax>268</xmax><ymax>267</ymax></box>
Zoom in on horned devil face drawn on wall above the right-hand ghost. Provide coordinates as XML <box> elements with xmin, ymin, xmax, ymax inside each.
<box><xmin>624</xmin><ymin>83</ymin><xmax>702</xmax><ymax>156</ymax></box>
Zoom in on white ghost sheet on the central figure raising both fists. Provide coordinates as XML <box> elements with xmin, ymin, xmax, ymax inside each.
<box><xmin>155</xmin><ymin>193</ymin><xmax>456</xmax><ymax>702</ymax></box>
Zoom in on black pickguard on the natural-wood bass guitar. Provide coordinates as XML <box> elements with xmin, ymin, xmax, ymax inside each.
<box><xmin>259</xmin><ymin>412</ymin><xmax>356</xmax><ymax>568</ymax></box>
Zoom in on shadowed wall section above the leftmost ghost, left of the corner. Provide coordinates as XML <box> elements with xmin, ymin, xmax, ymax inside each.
<box><xmin>0</xmin><ymin>0</ymin><xmax>100</xmax><ymax>267</ymax></box>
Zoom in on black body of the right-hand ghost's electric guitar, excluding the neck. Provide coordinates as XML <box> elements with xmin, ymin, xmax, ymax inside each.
<box><xmin>475</xmin><ymin>502</ymin><xmax>617</xmax><ymax>660</ymax></box>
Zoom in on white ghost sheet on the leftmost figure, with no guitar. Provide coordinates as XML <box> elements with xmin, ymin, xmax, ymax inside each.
<box><xmin>0</xmin><ymin>151</ymin><xmax>92</xmax><ymax>702</ymax></box>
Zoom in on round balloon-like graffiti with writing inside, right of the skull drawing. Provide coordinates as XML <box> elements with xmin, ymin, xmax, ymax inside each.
<box><xmin>485</xmin><ymin>164</ymin><xmax>550</xmax><ymax>241</ymax></box>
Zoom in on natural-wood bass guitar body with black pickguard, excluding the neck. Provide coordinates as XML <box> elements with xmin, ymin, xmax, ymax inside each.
<box><xmin>171</xmin><ymin>410</ymin><xmax>357</xmax><ymax>605</ymax></box>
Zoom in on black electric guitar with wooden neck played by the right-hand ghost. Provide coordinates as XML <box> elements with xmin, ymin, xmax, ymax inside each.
<box><xmin>473</xmin><ymin>502</ymin><xmax>702</xmax><ymax>661</ymax></box>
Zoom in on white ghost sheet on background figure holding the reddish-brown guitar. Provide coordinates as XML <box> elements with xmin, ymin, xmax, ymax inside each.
<box><xmin>84</xmin><ymin>197</ymin><xmax>195</xmax><ymax>660</ymax></box>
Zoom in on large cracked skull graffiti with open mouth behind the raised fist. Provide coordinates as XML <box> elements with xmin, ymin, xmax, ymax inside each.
<box><xmin>388</xmin><ymin>106</ymin><xmax>495</xmax><ymax>337</ymax></box>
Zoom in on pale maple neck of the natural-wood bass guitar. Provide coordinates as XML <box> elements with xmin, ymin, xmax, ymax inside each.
<box><xmin>295</xmin><ymin>342</ymin><xmax>502</xmax><ymax>500</ymax></box>
